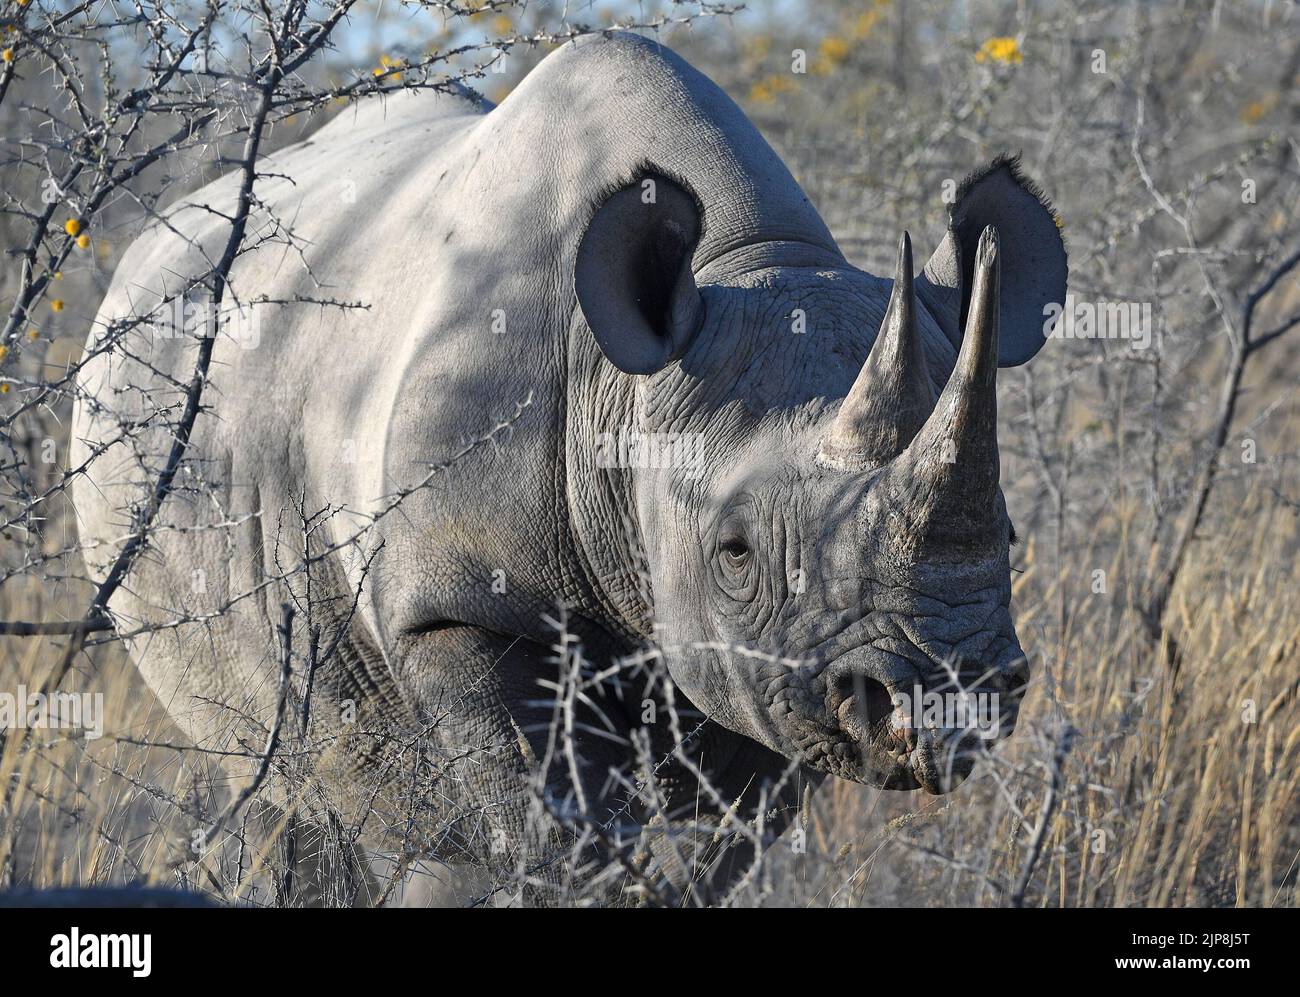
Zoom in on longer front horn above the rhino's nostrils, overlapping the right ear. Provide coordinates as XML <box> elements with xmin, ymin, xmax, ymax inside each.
<box><xmin>889</xmin><ymin>226</ymin><xmax>1001</xmax><ymax>546</ymax></box>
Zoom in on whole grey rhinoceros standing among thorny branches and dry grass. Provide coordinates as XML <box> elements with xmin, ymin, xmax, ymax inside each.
<box><xmin>72</xmin><ymin>32</ymin><xmax>1066</xmax><ymax>904</ymax></box>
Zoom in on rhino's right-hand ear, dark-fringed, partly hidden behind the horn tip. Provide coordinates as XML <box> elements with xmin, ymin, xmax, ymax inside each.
<box><xmin>917</xmin><ymin>156</ymin><xmax>1067</xmax><ymax>367</ymax></box>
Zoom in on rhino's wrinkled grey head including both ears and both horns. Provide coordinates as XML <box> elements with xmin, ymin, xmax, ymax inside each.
<box><xmin>575</xmin><ymin>160</ymin><xmax>1066</xmax><ymax>793</ymax></box>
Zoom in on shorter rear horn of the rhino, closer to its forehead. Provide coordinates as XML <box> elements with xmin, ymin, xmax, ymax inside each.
<box><xmin>819</xmin><ymin>233</ymin><xmax>935</xmax><ymax>471</ymax></box>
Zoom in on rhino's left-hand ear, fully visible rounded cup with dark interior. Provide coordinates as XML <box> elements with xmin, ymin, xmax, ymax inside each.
<box><xmin>573</xmin><ymin>173</ymin><xmax>705</xmax><ymax>374</ymax></box>
